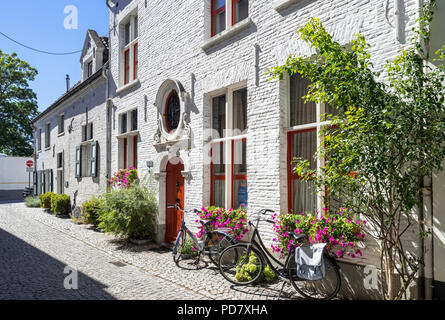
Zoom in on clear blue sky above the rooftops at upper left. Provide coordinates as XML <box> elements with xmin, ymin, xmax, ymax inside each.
<box><xmin>0</xmin><ymin>0</ymin><xmax>108</xmax><ymax>111</ymax></box>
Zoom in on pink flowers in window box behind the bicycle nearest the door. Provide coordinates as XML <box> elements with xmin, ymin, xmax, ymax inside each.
<box><xmin>195</xmin><ymin>206</ymin><xmax>248</xmax><ymax>241</ymax></box>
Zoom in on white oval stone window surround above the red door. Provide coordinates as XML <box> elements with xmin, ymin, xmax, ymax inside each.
<box><xmin>156</xmin><ymin>79</ymin><xmax>186</xmax><ymax>141</ymax></box>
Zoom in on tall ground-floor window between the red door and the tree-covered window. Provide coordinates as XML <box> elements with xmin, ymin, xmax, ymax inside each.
<box><xmin>210</xmin><ymin>88</ymin><xmax>248</xmax><ymax>208</ymax></box>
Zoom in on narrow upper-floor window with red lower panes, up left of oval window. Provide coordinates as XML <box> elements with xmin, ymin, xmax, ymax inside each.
<box><xmin>120</xmin><ymin>14</ymin><xmax>139</xmax><ymax>85</ymax></box>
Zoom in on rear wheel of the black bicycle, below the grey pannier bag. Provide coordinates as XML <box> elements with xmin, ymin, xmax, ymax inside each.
<box><xmin>290</xmin><ymin>254</ymin><xmax>341</xmax><ymax>300</ymax></box>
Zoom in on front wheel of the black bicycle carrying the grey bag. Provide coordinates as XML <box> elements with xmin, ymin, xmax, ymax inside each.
<box><xmin>219</xmin><ymin>243</ymin><xmax>264</xmax><ymax>286</ymax></box>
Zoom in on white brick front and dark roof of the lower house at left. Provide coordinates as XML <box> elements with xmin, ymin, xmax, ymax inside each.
<box><xmin>34</xmin><ymin>77</ymin><xmax>107</xmax><ymax>206</ymax></box>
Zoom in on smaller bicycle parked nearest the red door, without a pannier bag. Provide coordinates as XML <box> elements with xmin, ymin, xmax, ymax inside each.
<box><xmin>167</xmin><ymin>204</ymin><xmax>236</xmax><ymax>267</ymax></box>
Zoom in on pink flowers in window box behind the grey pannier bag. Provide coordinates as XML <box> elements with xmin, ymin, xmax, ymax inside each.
<box><xmin>271</xmin><ymin>208</ymin><xmax>366</xmax><ymax>259</ymax></box>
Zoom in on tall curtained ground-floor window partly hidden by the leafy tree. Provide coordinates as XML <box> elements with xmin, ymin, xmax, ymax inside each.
<box><xmin>286</xmin><ymin>74</ymin><xmax>336</xmax><ymax>213</ymax></box>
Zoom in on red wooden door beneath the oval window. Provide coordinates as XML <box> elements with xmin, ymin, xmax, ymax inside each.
<box><xmin>165</xmin><ymin>162</ymin><xmax>184</xmax><ymax>243</ymax></box>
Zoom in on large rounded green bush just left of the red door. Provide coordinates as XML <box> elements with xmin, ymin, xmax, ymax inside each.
<box><xmin>99</xmin><ymin>185</ymin><xmax>158</xmax><ymax>240</ymax></box>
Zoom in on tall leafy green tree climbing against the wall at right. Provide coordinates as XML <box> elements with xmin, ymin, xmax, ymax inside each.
<box><xmin>271</xmin><ymin>0</ymin><xmax>445</xmax><ymax>299</ymax></box>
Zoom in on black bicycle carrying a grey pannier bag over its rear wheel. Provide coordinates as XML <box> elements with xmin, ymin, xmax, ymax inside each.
<box><xmin>219</xmin><ymin>209</ymin><xmax>341</xmax><ymax>300</ymax></box>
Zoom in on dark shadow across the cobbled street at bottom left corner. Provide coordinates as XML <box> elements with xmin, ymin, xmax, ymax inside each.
<box><xmin>0</xmin><ymin>229</ymin><xmax>115</xmax><ymax>300</ymax></box>
